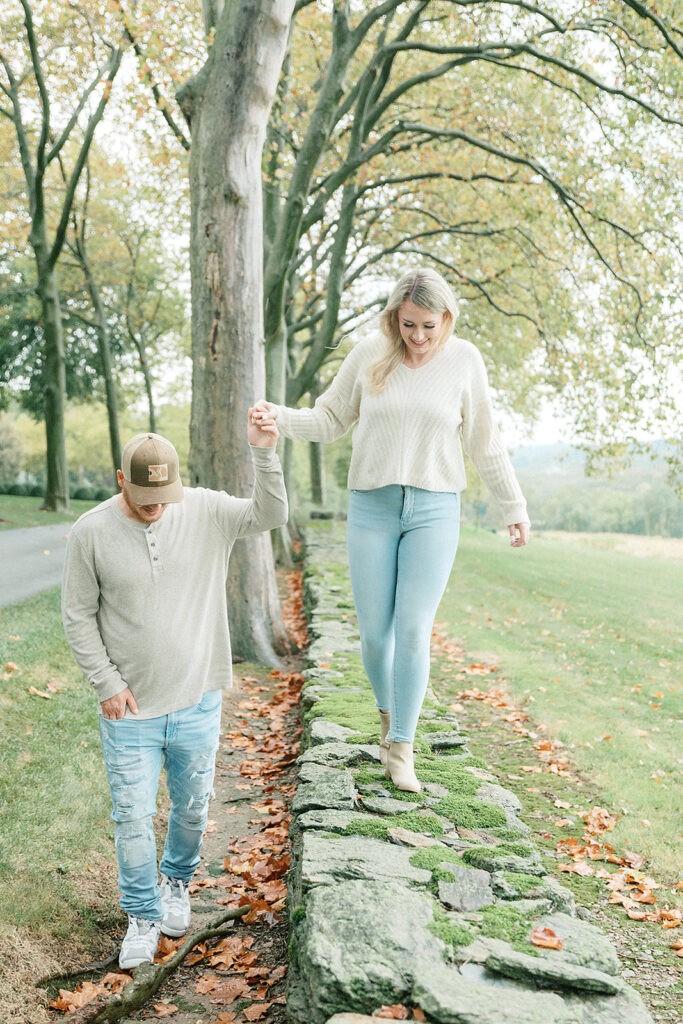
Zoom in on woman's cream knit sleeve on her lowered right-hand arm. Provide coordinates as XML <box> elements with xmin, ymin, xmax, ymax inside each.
<box><xmin>462</xmin><ymin>349</ymin><xmax>529</xmax><ymax>526</ymax></box>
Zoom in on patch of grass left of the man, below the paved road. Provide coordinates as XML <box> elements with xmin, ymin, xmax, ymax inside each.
<box><xmin>0</xmin><ymin>588</ymin><xmax>117</xmax><ymax>938</ymax></box>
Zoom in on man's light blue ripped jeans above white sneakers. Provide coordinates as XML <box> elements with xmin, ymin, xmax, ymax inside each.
<box><xmin>99</xmin><ymin>690</ymin><xmax>221</xmax><ymax>921</ymax></box>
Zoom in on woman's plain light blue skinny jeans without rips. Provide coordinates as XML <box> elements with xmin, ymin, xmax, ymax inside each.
<box><xmin>347</xmin><ymin>484</ymin><xmax>460</xmax><ymax>742</ymax></box>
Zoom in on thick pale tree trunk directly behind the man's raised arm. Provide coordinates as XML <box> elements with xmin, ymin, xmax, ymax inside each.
<box><xmin>178</xmin><ymin>0</ymin><xmax>294</xmax><ymax>664</ymax></box>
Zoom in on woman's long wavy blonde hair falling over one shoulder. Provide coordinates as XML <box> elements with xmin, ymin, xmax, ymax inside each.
<box><xmin>369</xmin><ymin>266</ymin><xmax>458</xmax><ymax>393</ymax></box>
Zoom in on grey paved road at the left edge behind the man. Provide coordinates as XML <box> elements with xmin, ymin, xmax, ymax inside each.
<box><xmin>0</xmin><ymin>522</ymin><xmax>71</xmax><ymax>607</ymax></box>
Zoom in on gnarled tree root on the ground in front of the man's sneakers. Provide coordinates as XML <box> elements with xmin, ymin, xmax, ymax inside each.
<box><xmin>61</xmin><ymin>904</ymin><xmax>251</xmax><ymax>1024</ymax></box>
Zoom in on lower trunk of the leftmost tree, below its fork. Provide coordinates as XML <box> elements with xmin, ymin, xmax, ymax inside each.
<box><xmin>32</xmin><ymin>241</ymin><xmax>71</xmax><ymax>512</ymax></box>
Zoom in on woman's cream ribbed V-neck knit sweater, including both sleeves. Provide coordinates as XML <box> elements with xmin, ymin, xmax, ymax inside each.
<box><xmin>278</xmin><ymin>336</ymin><xmax>528</xmax><ymax>525</ymax></box>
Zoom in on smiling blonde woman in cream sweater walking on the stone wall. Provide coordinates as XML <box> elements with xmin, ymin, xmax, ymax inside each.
<box><xmin>254</xmin><ymin>268</ymin><xmax>528</xmax><ymax>793</ymax></box>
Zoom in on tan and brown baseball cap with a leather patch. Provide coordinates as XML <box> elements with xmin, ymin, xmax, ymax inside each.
<box><xmin>121</xmin><ymin>434</ymin><xmax>184</xmax><ymax>505</ymax></box>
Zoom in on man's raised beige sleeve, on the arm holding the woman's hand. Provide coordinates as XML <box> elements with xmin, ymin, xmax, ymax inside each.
<box><xmin>209</xmin><ymin>444</ymin><xmax>288</xmax><ymax>543</ymax></box>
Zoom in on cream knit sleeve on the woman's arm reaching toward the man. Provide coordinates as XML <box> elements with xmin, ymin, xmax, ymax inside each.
<box><xmin>278</xmin><ymin>343</ymin><xmax>365</xmax><ymax>444</ymax></box>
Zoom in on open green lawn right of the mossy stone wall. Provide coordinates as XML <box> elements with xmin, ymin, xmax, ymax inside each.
<box><xmin>437</xmin><ymin>527</ymin><xmax>683</xmax><ymax>880</ymax></box>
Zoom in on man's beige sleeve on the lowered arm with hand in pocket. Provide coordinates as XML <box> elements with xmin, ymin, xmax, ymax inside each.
<box><xmin>61</xmin><ymin>530</ymin><xmax>128</xmax><ymax>702</ymax></box>
